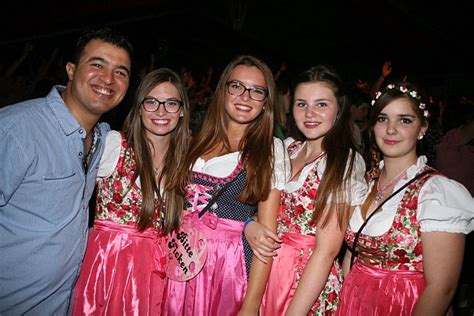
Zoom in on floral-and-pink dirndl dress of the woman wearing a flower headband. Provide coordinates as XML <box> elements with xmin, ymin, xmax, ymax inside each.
<box><xmin>336</xmin><ymin>167</ymin><xmax>433</xmax><ymax>316</ymax></box>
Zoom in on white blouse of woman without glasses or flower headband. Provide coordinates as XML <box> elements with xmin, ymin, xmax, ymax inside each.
<box><xmin>285</xmin><ymin>137</ymin><xmax>367</xmax><ymax>206</ymax></box>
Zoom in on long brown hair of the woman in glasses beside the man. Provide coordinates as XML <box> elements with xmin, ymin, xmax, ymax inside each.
<box><xmin>124</xmin><ymin>68</ymin><xmax>190</xmax><ymax>235</ymax></box>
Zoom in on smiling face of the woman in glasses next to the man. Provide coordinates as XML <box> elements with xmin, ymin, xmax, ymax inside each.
<box><xmin>140</xmin><ymin>82</ymin><xmax>183</xmax><ymax>139</ymax></box>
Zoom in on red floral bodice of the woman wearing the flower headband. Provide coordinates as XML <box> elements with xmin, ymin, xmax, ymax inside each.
<box><xmin>345</xmin><ymin>166</ymin><xmax>437</xmax><ymax>272</ymax></box>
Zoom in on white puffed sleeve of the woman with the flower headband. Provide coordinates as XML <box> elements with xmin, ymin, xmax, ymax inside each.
<box><xmin>417</xmin><ymin>176</ymin><xmax>474</xmax><ymax>234</ymax></box>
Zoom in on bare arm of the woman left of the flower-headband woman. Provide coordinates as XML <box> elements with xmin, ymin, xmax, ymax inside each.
<box><xmin>286</xmin><ymin>204</ymin><xmax>346</xmax><ymax>316</ymax></box>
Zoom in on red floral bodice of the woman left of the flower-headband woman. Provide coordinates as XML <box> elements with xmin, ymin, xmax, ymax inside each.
<box><xmin>277</xmin><ymin>141</ymin><xmax>324</xmax><ymax>236</ymax></box>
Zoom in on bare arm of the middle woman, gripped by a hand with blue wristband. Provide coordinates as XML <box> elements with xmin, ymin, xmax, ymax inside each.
<box><xmin>238</xmin><ymin>189</ymin><xmax>280</xmax><ymax>316</ymax></box>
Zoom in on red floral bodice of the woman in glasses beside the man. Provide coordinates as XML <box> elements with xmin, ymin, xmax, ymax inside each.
<box><xmin>95</xmin><ymin>133</ymin><xmax>161</xmax><ymax>229</ymax></box>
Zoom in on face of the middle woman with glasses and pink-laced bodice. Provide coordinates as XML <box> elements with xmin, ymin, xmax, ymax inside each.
<box><xmin>224</xmin><ymin>65</ymin><xmax>267</xmax><ymax>129</ymax></box>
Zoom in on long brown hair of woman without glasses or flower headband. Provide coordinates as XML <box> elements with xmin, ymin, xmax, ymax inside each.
<box><xmin>291</xmin><ymin>65</ymin><xmax>357</xmax><ymax>227</ymax></box>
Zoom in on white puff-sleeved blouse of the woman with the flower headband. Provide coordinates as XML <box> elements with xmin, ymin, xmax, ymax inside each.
<box><xmin>349</xmin><ymin>156</ymin><xmax>474</xmax><ymax>236</ymax></box>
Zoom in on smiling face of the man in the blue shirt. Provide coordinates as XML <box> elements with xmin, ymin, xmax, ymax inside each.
<box><xmin>64</xmin><ymin>39</ymin><xmax>131</xmax><ymax>124</ymax></box>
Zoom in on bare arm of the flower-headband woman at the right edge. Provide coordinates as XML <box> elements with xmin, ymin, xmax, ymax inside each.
<box><xmin>413</xmin><ymin>232</ymin><xmax>465</xmax><ymax>316</ymax></box>
